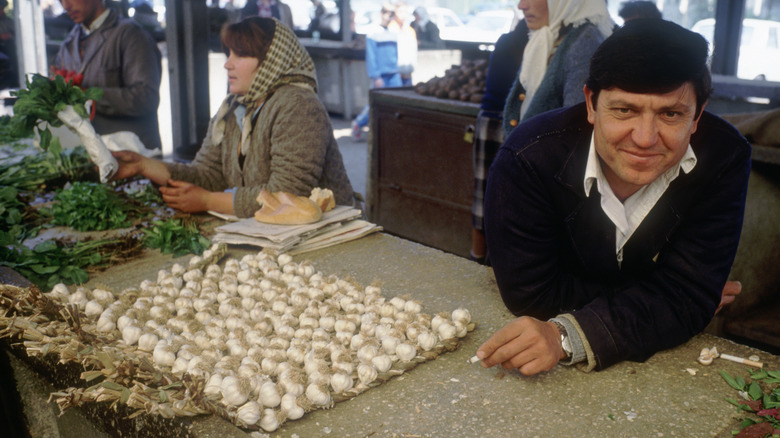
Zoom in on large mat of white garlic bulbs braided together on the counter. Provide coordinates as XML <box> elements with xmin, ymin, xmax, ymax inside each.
<box><xmin>49</xmin><ymin>248</ymin><xmax>474</xmax><ymax>432</ymax></box>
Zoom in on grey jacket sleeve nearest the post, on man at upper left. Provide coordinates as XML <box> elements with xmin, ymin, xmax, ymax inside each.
<box><xmin>95</xmin><ymin>23</ymin><xmax>161</xmax><ymax>117</ymax></box>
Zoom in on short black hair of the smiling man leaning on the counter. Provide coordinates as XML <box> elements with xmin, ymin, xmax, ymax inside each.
<box><xmin>585</xmin><ymin>18</ymin><xmax>712</xmax><ymax>117</ymax></box>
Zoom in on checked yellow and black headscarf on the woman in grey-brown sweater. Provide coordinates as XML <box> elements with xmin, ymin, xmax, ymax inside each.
<box><xmin>211</xmin><ymin>18</ymin><xmax>317</xmax><ymax>151</ymax></box>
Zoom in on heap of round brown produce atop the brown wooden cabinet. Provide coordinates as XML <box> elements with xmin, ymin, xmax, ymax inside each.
<box><xmin>414</xmin><ymin>59</ymin><xmax>488</xmax><ymax>103</ymax></box>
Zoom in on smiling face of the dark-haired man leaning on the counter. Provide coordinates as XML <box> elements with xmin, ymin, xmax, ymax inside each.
<box><xmin>585</xmin><ymin>82</ymin><xmax>699</xmax><ymax>200</ymax></box>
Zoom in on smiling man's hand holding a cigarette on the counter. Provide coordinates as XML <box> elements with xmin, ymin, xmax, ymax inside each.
<box><xmin>477</xmin><ymin>316</ymin><xmax>566</xmax><ymax>376</ymax></box>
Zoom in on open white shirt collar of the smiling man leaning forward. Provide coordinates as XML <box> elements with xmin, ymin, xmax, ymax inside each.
<box><xmin>583</xmin><ymin>134</ymin><xmax>696</xmax><ymax>264</ymax></box>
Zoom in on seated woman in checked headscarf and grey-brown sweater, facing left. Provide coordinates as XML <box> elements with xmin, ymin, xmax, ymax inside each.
<box><xmin>113</xmin><ymin>17</ymin><xmax>355</xmax><ymax>217</ymax></box>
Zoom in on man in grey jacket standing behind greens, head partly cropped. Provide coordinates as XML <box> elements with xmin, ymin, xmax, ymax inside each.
<box><xmin>52</xmin><ymin>0</ymin><xmax>162</xmax><ymax>153</ymax></box>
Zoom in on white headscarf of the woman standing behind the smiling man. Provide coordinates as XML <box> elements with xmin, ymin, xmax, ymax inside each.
<box><xmin>519</xmin><ymin>0</ymin><xmax>615</xmax><ymax>117</ymax></box>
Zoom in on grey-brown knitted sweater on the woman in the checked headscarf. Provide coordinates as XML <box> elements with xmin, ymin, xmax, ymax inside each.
<box><xmin>166</xmin><ymin>85</ymin><xmax>354</xmax><ymax>217</ymax></box>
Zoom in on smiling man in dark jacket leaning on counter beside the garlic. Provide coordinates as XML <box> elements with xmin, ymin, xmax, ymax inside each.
<box><xmin>477</xmin><ymin>19</ymin><xmax>750</xmax><ymax>374</ymax></box>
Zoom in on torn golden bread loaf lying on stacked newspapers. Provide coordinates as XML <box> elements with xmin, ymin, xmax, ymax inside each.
<box><xmin>255</xmin><ymin>190</ymin><xmax>322</xmax><ymax>225</ymax></box>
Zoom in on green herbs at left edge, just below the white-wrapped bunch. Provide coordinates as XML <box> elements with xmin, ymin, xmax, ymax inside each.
<box><xmin>0</xmin><ymin>146</ymin><xmax>97</xmax><ymax>192</ymax></box>
